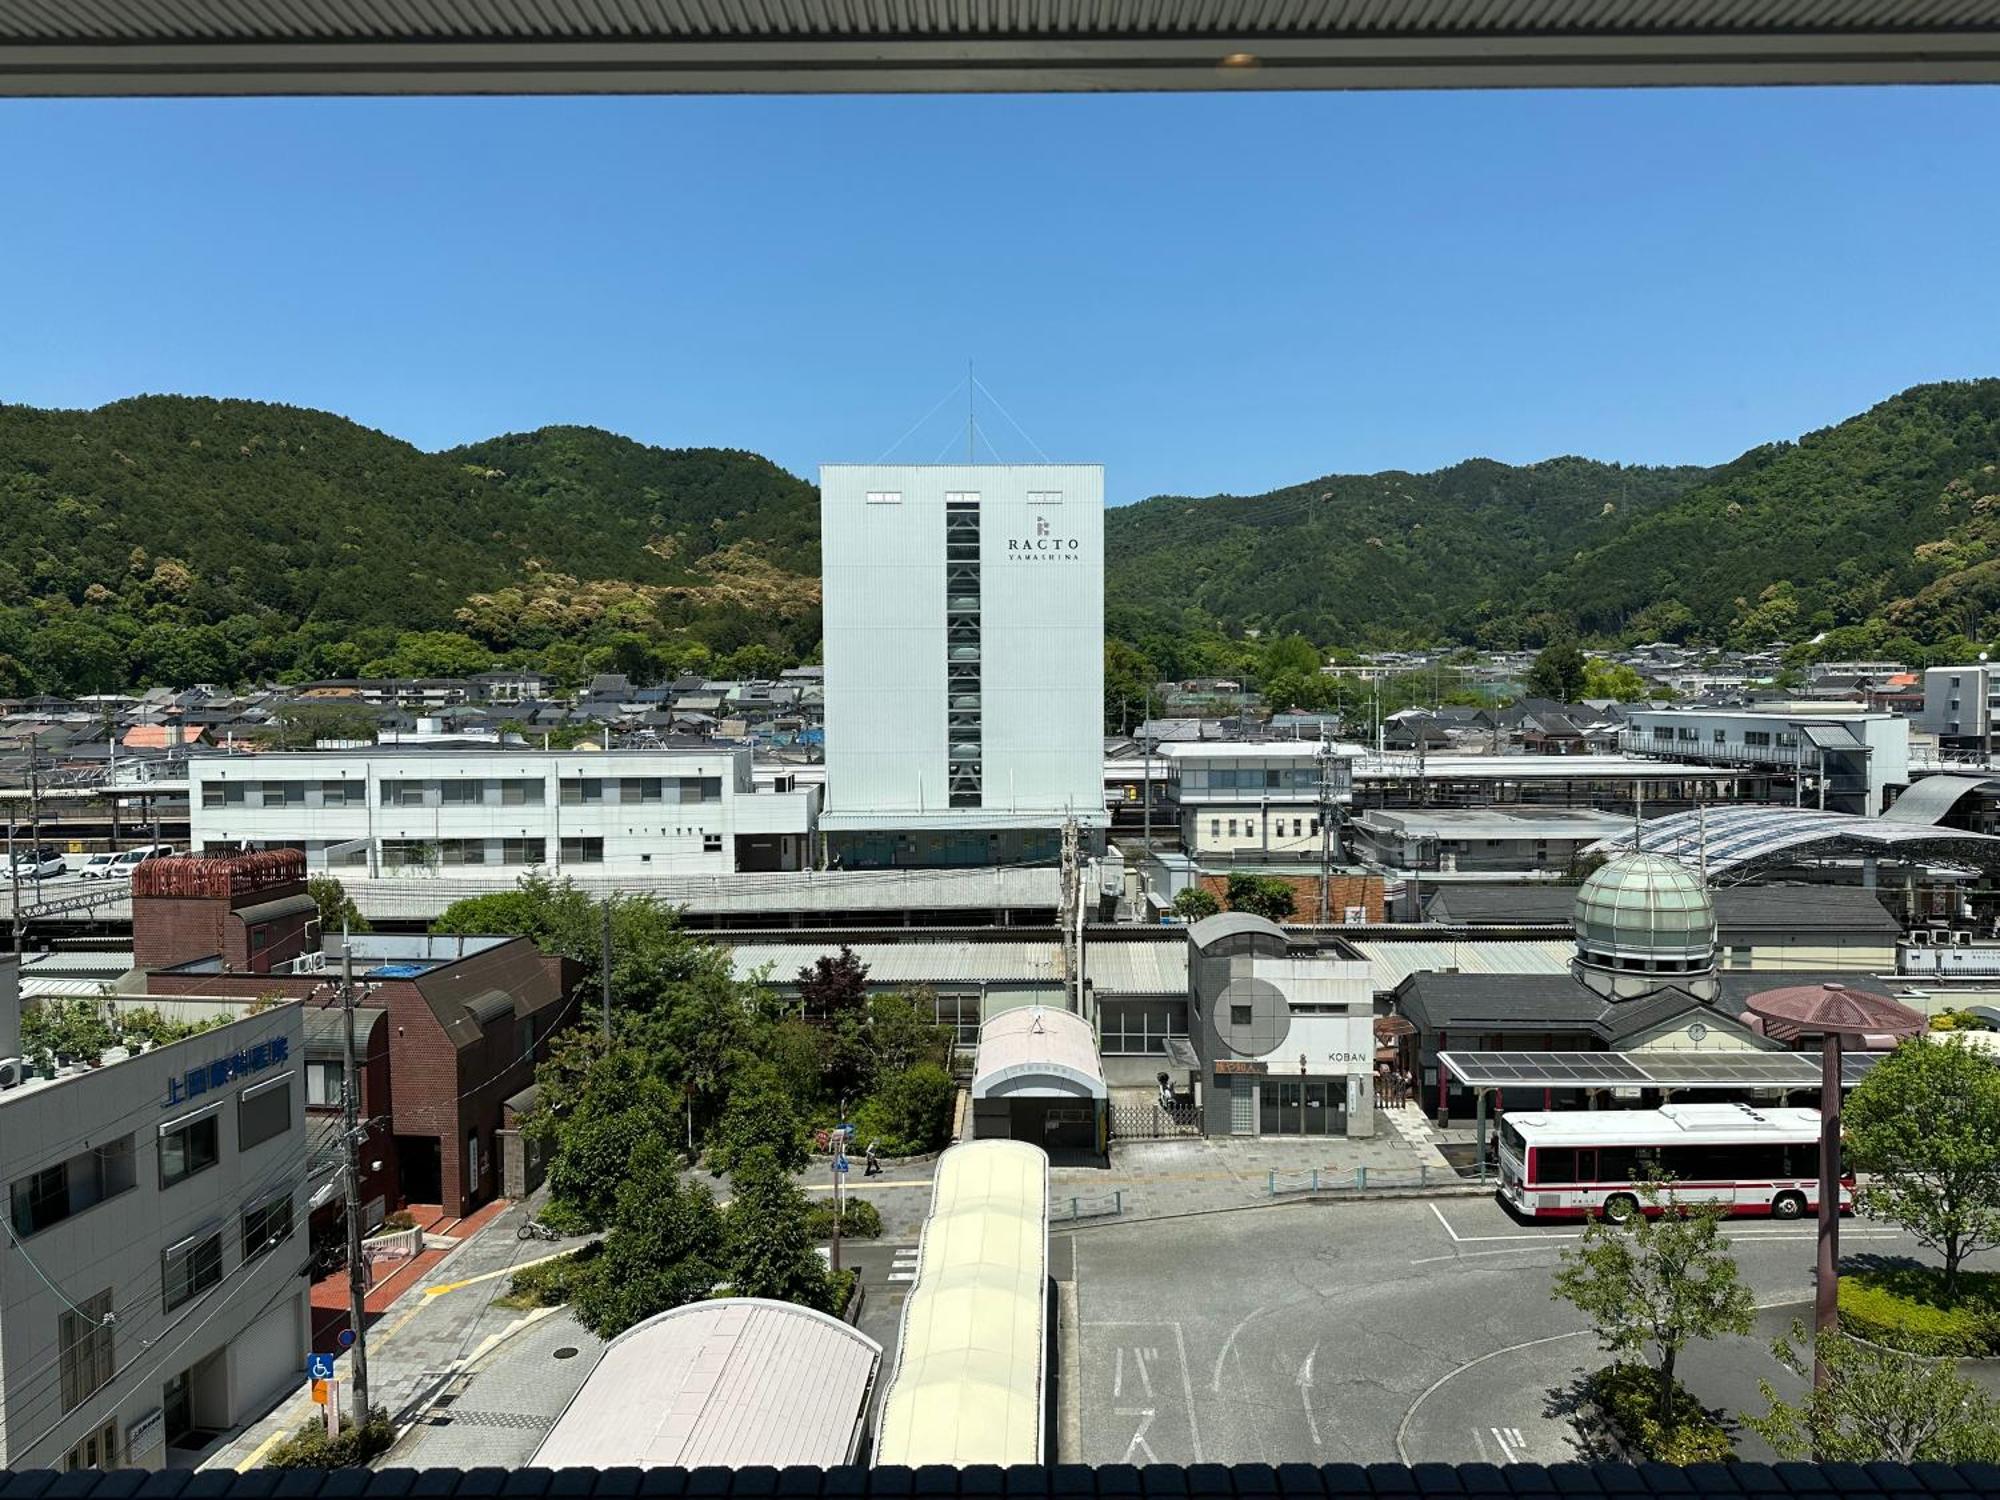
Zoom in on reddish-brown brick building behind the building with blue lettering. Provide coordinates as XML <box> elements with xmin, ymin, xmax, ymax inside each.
<box><xmin>132</xmin><ymin>850</ymin><xmax>576</xmax><ymax>1214</ymax></box>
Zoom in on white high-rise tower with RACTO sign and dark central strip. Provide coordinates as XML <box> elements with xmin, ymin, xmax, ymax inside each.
<box><xmin>820</xmin><ymin>464</ymin><xmax>1104</xmax><ymax>866</ymax></box>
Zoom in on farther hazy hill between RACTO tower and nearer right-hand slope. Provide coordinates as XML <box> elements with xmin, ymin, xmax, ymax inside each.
<box><xmin>1106</xmin><ymin>458</ymin><xmax>1706</xmax><ymax>644</ymax></box>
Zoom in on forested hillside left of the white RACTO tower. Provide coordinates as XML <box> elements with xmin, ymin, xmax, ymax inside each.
<box><xmin>0</xmin><ymin>396</ymin><xmax>818</xmax><ymax>694</ymax></box>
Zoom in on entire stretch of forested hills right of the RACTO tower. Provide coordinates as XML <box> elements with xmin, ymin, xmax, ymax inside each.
<box><xmin>1106</xmin><ymin>380</ymin><xmax>2000</xmax><ymax>660</ymax></box>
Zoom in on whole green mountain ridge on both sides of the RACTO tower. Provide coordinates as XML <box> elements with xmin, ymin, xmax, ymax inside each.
<box><xmin>0</xmin><ymin>380</ymin><xmax>2000</xmax><ymax>694</ymax></box>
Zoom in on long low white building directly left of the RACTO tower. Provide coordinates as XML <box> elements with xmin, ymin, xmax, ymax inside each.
<box><xmin>188</xmin><ymin>746</ymin><xmax>818</xmax><ymax>884</ymax></box>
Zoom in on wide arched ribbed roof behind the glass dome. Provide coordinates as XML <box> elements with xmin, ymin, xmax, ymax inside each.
<box><xmin>1590</xmin><ymin>804</ymin><xmax>2000</xmax><ymax>880</ymax></box>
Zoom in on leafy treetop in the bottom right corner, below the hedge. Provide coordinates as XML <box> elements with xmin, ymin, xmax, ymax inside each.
<box><xmin>1744</xmin><ymin>1322</ymin><xmax>2000</xmax><ymax>1464</ymax></box>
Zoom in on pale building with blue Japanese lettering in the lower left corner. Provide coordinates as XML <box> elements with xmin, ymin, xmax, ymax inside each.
<box><xmin>0</xmin><ymin>964</ymin><xmax>310</xmax><ymax>1470</ymax></box>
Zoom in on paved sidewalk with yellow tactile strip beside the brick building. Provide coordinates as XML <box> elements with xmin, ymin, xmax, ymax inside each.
<box><xmin>202</xmin><ymin>1202</ymin><xmax>582</xmax><ymax>1470</ymax></box>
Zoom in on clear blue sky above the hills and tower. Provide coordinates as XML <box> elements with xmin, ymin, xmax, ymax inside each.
<box><xmin>0</xmin><ymin>88</ymin><xmax>2000</xmax><ymax>502</ymax></box>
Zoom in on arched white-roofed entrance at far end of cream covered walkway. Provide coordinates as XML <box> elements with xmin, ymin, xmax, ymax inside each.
<box><xmin>972</xmin><ymin>1006</ymin><xmax>1112</xmax><ymax>1156</ymax></box>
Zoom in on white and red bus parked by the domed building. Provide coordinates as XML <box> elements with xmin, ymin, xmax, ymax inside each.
<box><xmin>1500</xmin><ymin>1104</ymin><xmax>1854</xmax><ymax>1218</ymax></box>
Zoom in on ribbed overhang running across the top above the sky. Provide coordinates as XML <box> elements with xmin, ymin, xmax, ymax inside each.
<box><xmin>0</xmin><ymin>0</ymin><xmax>2000</xmax><ymax>96</ymax></box>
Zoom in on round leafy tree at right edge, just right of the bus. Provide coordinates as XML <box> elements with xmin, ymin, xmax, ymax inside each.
<box><xmin>1840</xmin><ymin>1038</ymin><xmax>2000</xmax><ymax>1296</ymax></box>
